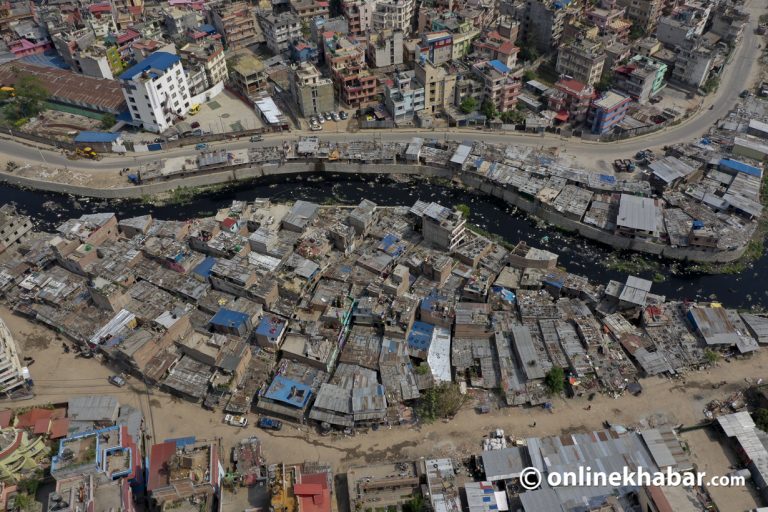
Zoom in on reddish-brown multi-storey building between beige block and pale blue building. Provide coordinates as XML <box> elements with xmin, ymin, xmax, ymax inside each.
<box><xmin>325</xmin><ymin>35</ymin><xmax>379</xmax><ymax>107</ymax></box>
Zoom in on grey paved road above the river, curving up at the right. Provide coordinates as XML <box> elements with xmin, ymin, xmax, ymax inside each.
<box><xmin>0</xmin><ymin>0</ymin><xmax>765</xmax><ymax>174</ymax></box>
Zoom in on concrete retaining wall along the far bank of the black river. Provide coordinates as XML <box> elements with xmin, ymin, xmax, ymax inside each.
<box><xmin>0</xmin><ymin>161</ymin><xmax>746</xmax><ymax>263</ymax></box>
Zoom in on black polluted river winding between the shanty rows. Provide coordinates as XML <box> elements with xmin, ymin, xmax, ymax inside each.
<box><xmin>0</xmin><ymin>176</ymin><xmax>768</xmax><ymax>309</ymax></box>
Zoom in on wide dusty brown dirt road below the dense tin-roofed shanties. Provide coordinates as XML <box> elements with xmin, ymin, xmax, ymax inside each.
<box><xmin>0</xmin><ymin>308</ymin><xmax>768</xmax><ymax>511</ymax></box>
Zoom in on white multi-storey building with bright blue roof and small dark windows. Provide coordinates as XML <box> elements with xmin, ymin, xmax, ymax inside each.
<box><xmin>120</xmin><ymin>52</ymin><xmax>190</xmax><ymax>133</ymax></box>
